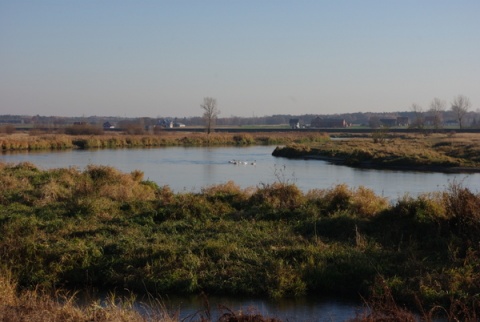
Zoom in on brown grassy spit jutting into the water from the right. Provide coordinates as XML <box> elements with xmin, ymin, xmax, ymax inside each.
<box><xmin>273</xmin><ymin>134</ymin><xmax>480</xmax><ymax>172</ymax></box>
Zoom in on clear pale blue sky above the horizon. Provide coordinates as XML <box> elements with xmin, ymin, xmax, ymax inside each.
<box><xmin>0</xmin><ymin>0</ymin><xmax>480</xmax><ymax>117</ymax></box>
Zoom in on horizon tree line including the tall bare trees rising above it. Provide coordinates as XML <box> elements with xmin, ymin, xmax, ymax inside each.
<box><xmin>0</xmin><ymin>95</ymin><xmax>480</xmax><ymax>134</ymax></box>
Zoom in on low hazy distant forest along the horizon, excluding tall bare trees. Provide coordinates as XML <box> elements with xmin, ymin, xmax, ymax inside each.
<box><xmin>0</xmin><ymin>110</ymin><xmax>480</xmax><ymax>128</ymax></box>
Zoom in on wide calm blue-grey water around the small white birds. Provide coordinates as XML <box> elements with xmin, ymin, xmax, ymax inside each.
<box><xmin>1</xmin><ymin>146</ymin><xmax>480</xmax><ymax>199</ymax></box>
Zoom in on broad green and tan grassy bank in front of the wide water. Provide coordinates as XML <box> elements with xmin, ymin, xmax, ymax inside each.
<box><xmin>0</xmin><ymin>163</ymin><xmax>480</xmax><ymax>317</ymax></box>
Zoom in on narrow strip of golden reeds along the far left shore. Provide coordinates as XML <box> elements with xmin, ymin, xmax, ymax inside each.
<box><xmin>0</xmin><ymin>132</ymin><xmax>328</xmax><ymax>151</ymax></box>
